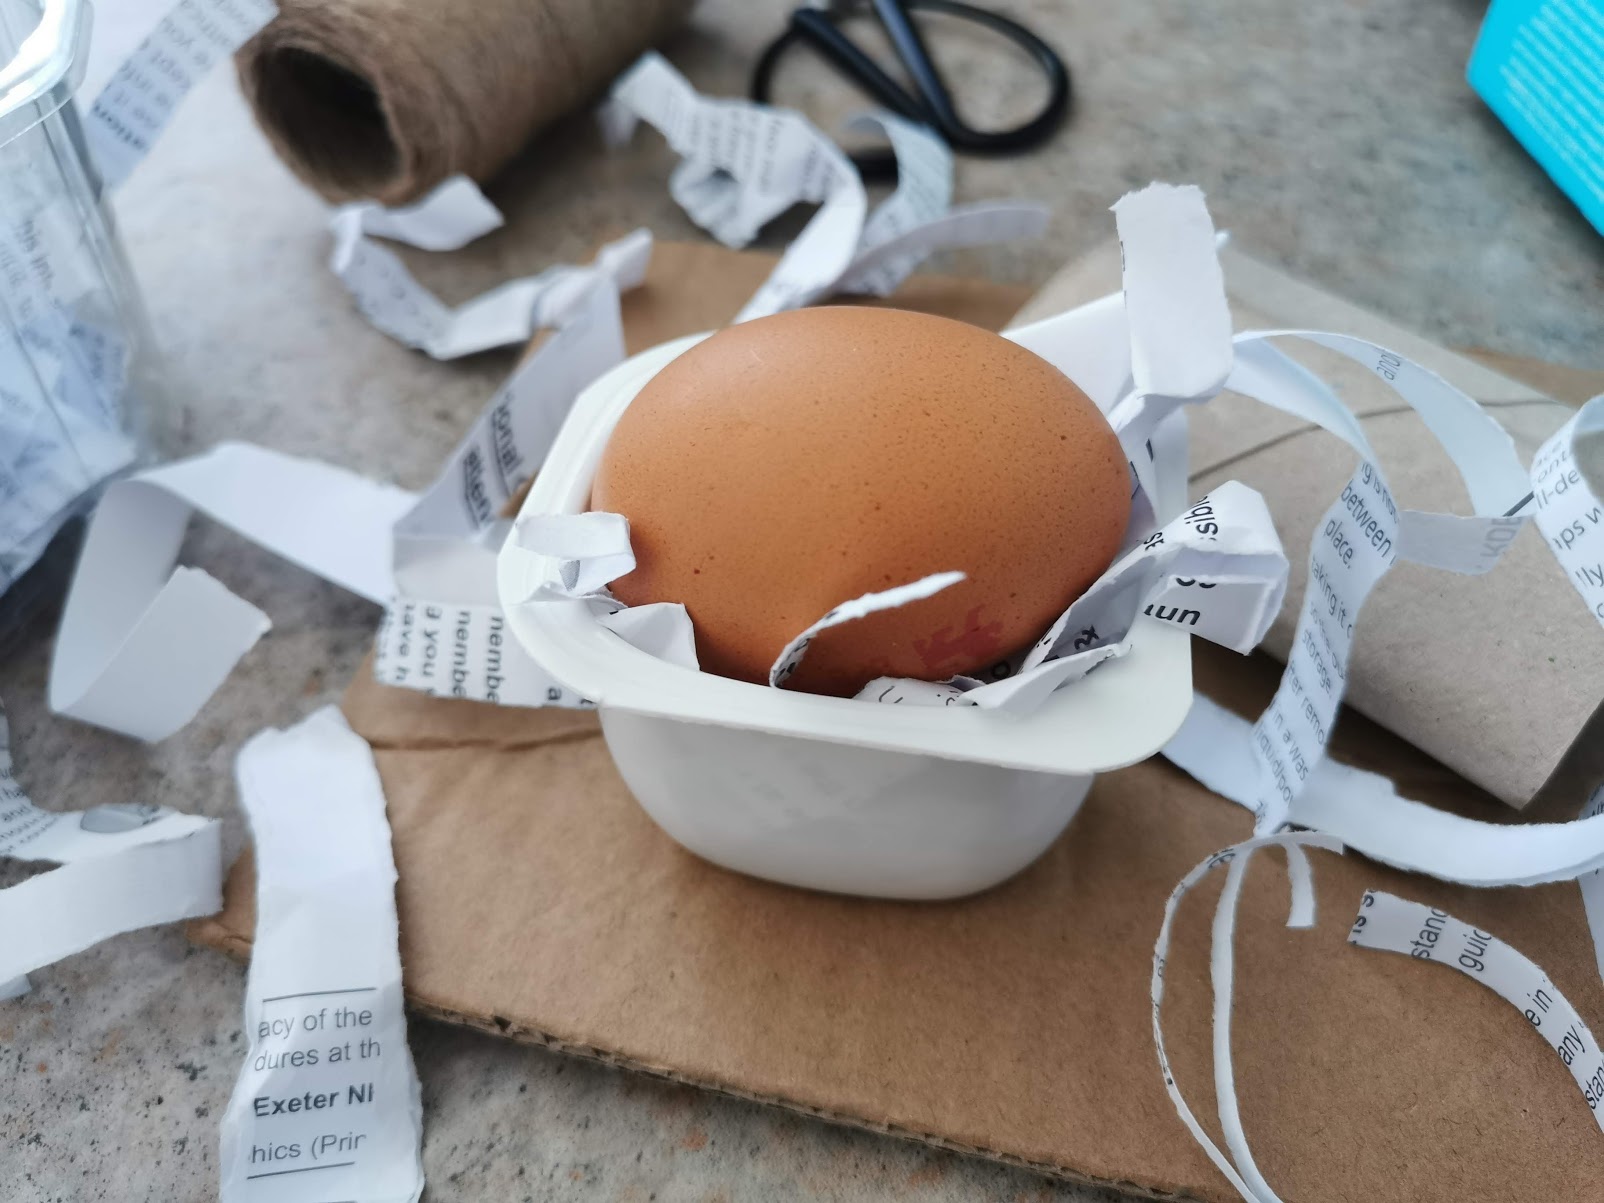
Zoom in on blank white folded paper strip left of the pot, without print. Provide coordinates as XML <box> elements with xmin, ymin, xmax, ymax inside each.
<box><xmin>50</xmin><ymin>443</ymin><xmax>414</xmax><ymax>739</ymax></box>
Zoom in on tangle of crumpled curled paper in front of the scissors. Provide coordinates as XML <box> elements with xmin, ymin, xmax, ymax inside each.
<box><xmin>600</xmin><ymin>53</ymin><xmax>1047</xmax><ymax>322</ymax></box>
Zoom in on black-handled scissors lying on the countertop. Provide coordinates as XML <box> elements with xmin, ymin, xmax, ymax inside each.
<box><xmin>752</xmin><ymin>0</ymin><xmax>1070</xmax><ymax>180</ymax></box>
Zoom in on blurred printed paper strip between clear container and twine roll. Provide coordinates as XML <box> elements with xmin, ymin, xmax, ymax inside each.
<box><xmin>83</xmin><ymin>0</ymin><xmax>279</xmax><ymax>188</ymax></box>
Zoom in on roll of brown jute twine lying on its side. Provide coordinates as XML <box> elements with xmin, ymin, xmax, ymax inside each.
<box><xmin>236</xmin><ymin>0</ymin><xmax>695</xmax><ymax>205</ymax></box>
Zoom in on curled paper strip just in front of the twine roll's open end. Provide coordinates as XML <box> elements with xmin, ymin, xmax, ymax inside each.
<box><xmin>329</xmin><ymin>175</ymin><xmax>651</xmax><ymax>359</ymax></box>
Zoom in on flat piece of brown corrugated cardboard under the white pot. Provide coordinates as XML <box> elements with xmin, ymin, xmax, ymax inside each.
<box><xmin>192</xmin><ymin>245</ymin><xmax>1604</xmax><ymax>1203</ymax></box>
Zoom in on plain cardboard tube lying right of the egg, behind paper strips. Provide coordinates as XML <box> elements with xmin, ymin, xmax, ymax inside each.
<box><xmin>1017</xmin><ymin>245</ymin><xmax>1604</xmax><ymax>818</ymax></box>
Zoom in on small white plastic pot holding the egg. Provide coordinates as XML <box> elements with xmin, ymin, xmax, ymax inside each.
<box><xmin>497</xmin><ymin>311</ymin><xmax>1192</xmax><ymax>898</ymax></box>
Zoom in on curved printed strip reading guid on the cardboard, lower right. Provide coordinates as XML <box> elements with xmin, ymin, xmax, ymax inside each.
<box><xmin>1347</xmin><ymin>890</ymin><xmax>1604</xmax><ymax>1132</ymax></box>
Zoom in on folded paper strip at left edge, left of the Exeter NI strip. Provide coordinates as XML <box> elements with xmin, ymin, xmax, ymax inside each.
<box><xmin>0</xmin><ymin>696</ymin><xmax>223</xmax><ymax>999</ymax></box>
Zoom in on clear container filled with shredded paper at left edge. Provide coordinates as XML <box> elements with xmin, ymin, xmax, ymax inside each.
<box><xmin>0</xmin><ymin>0</ymin><xmax>151</xmax><ymax>653</ymax></box>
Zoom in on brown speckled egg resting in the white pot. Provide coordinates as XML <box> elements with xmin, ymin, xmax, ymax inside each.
<box><xmin>590</xmin><ymin>305</ymin><xmax>1131</xmax><ymax>695</ymax></box>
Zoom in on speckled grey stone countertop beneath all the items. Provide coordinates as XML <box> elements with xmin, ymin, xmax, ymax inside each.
<box><xmin>0</xmin><ymin>0</ymin><xmax>1604</xmax><ymax>1203</ymax></box>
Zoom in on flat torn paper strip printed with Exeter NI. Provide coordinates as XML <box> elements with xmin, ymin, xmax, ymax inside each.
<box><xmin>220</xmin><ymin>706</ymin><xmax>423</xmax><ymax>1203</ymax></box>
